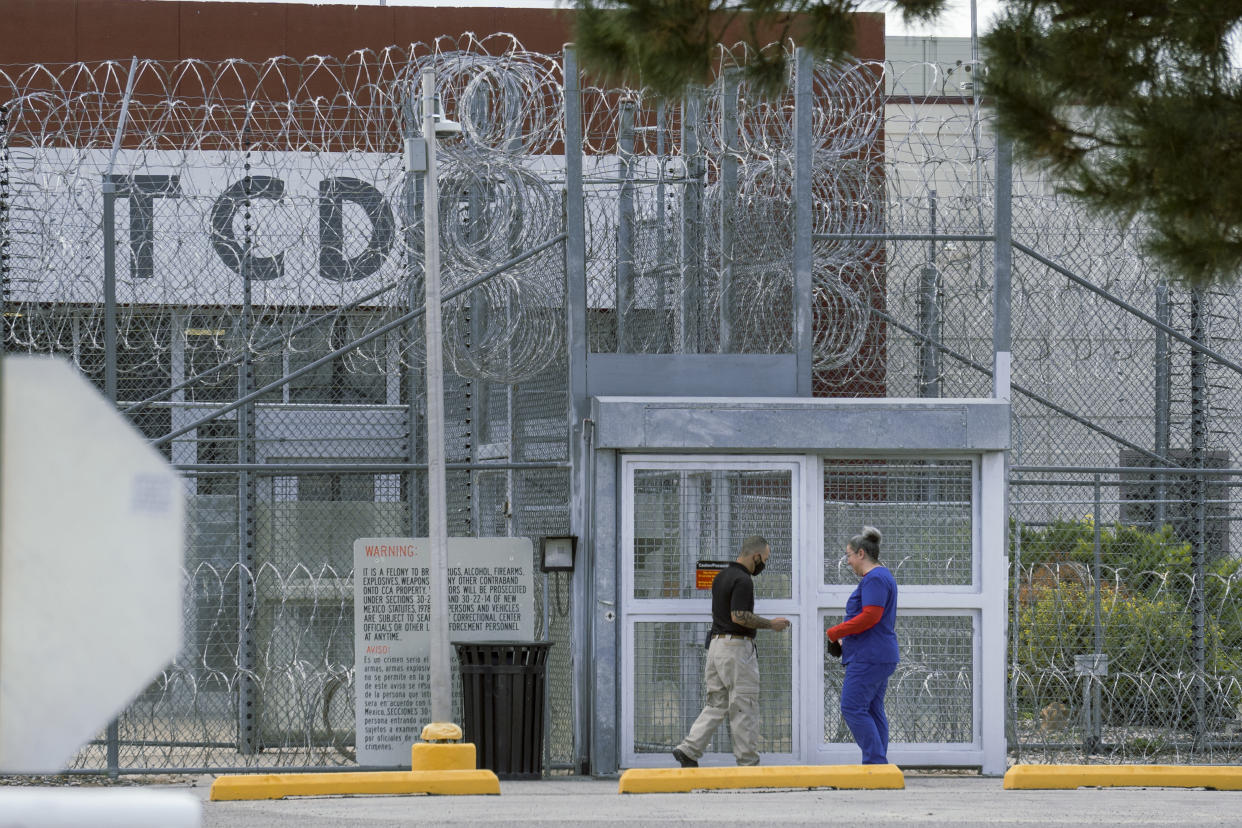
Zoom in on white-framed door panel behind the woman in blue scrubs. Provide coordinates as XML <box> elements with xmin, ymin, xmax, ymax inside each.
<box><xmin>809</xmin><ymin>457</ymin><xmax>988</xmax><ymax>765</ymax></box>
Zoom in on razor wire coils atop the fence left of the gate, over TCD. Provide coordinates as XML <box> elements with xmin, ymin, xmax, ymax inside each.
<box><xmin>0</xmin><ymin>35</ymin><xmax>564</xmax><ymax>400</ymax></box>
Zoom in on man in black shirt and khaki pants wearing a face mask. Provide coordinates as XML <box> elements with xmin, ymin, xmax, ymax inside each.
<box><xmin>673</xmin><ymin>535</ymin><xmax>789</xmax><ymax>767</ymax></box>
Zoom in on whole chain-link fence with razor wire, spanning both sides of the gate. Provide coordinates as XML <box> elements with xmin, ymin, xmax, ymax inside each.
<box><xmin>7</xmin><ymin>30</ymin><xmax>1242</xmax><ymax>771</ymax></box>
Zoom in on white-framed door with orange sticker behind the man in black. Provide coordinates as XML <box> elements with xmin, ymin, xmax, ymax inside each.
<box><xmin>621</xmin><ymin>457</ymin><xmax>805</xmax><ymax>767</ymax></box>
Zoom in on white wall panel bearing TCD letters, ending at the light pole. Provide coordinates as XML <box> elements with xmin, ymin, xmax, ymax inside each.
<box><xmin>11</xmin><ymin>148</ymin><xmax>405</xmax><ymax>305</ymax></box>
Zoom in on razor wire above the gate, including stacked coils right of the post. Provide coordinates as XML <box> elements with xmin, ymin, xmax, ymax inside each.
<box><xmin>584</xmin><ymin>48</ymin><xmax>886</xmax><ymax>394</ymax></box>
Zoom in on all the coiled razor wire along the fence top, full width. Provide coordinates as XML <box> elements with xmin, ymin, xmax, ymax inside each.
<box><xmin>7</xmin><ymin>35</ymin><xmax>1242</xmax><ymax>459</ymax></box>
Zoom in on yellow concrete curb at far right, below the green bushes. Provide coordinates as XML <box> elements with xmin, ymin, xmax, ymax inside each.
<box><xmin>1005</xmin><ymin>765</ymin><xmax>1242</xmax><ymax>791</ymax></box>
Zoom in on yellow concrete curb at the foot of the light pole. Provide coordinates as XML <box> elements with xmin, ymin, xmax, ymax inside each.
<box><xmin>211</xmin><ymin>771</ymin><xmax>501</xmax><ymax>801</ymax></box>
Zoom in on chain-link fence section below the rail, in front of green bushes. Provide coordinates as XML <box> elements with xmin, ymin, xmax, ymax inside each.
<box><xmin>1009</xmin><ymin>467</ymin><xmax>1242</xmax><ymax>763</ymax></box>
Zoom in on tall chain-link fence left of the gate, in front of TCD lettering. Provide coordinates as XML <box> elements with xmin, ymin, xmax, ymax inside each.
<box><xmin>0</xmin><ymin>36</ymin><xmax>575</xmax><ymax>771</ymax></box>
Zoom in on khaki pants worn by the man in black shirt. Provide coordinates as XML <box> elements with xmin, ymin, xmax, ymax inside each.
<box><xmin>677</xmin><ymin>638</ymin><xmax>759</xmax><ymax>765</ymax></box>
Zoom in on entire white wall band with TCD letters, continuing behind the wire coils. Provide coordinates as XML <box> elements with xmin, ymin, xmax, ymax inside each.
<box><xmin>9</xmin><ymin>146</ymin><xmax>583</xmax><ymax>307</ymax></box>
